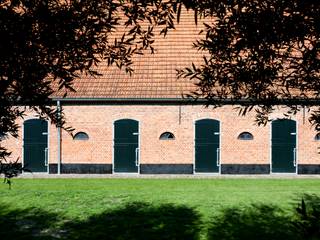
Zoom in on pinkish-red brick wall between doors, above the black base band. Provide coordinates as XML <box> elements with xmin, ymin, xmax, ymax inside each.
<box><xmin>4</xmin><ymin>105</ymin><xmax>320</xmax><ymax>169</ymax></box>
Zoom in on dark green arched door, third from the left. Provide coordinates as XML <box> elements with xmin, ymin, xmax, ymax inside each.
<box><xmin>195</xmin><ymin>119</ymin><xmax>220</xmax><ymax>172</ymax></box>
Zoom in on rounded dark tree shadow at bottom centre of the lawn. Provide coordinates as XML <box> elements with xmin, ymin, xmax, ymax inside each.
<box><xmin>67</xmin><ymin>202</ymin><xmax>201</xmax><ymax>240</ymax></box>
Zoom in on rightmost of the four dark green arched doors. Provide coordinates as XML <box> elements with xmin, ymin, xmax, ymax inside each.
<box><xmin>271</xmin><ymin>119</ymin><xmax>297</xmax><ymax>173</ymax></box>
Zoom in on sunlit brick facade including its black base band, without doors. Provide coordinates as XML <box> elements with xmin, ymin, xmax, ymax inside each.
<box><xmin>6</xmin><ymin>103</ymin><xmax>320</xmax><ymax>174</ymax></box>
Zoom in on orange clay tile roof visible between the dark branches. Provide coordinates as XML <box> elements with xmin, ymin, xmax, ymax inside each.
<box><xmin>53</xmin><ymin>12</ymin><xmax>203</xmax><ymax>99</ymax></box>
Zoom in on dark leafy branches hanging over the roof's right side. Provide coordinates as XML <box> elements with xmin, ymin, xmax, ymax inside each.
<box><xmin>178</xmin><ymin>0</ymin><xmax>320</xmax><ymax>127</ymax></box>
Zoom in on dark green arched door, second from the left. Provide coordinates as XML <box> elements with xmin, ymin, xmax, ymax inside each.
<box><xmin>114</xmin><ymin>119</ymin><xmax>139</xmax><ymax>173</ymax></box>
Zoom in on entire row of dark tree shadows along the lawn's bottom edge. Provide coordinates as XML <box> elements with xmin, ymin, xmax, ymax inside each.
<box><xmin>0</xmin><ymin>195</ymin><xmax>320</xmax><ymax>240</ymax></box>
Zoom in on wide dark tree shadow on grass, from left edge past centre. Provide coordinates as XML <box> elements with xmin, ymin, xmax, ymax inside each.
<box><xmin>0</xmin><ymin>203</ymin><xmax>201</xmax><ymax>240</ymax></box>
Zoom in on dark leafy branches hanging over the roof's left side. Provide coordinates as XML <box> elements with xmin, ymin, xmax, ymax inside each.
<box><xmin>0</xmin><ymin>0</ymin><xmax>180</xmax><ymax>176</ymax></box>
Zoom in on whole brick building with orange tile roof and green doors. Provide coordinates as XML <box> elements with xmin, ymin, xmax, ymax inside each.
<box><xmin>4</xmin><ymin>11</ymin><xmax>320</xmax><ymax>174</ymax></box>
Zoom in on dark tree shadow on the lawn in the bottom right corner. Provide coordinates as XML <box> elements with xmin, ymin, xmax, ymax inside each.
<box><xmin>207</xmin><ymin>194</ymin><xmax>320</xmax><ymax>240</ymax></box>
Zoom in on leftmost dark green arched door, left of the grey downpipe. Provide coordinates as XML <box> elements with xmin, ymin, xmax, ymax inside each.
<box><xmin>23</xmin><ymin>119</ymin><xmax>48</xmax><ymax>172</ymax></box>
